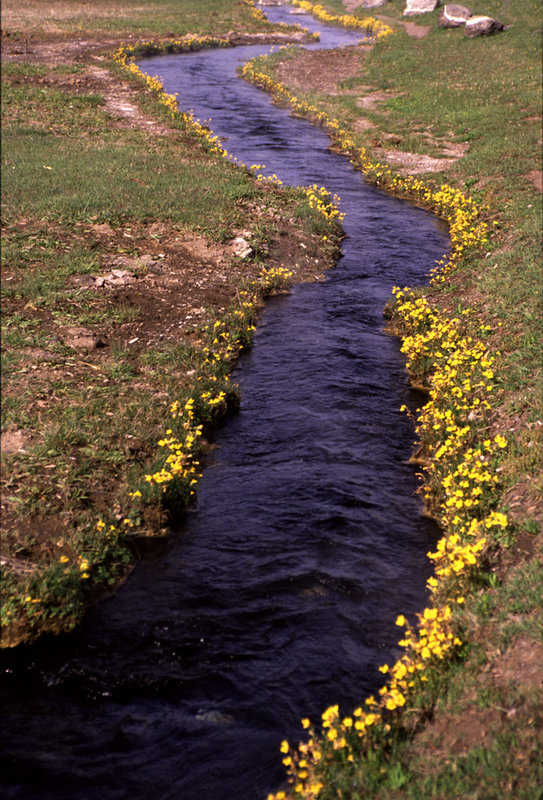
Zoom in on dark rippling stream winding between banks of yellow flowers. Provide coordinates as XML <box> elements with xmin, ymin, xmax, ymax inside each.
<box><xmin>0</xmin><ymin>9</ymin><xmax>448</xmax><ymax>800</ymax></box>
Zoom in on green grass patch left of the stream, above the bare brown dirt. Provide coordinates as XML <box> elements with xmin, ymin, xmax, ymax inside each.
<box><xmin>3</xmin><ymin>65</ymin><xmax>268</xmax><ymax>228</ymax></box>
